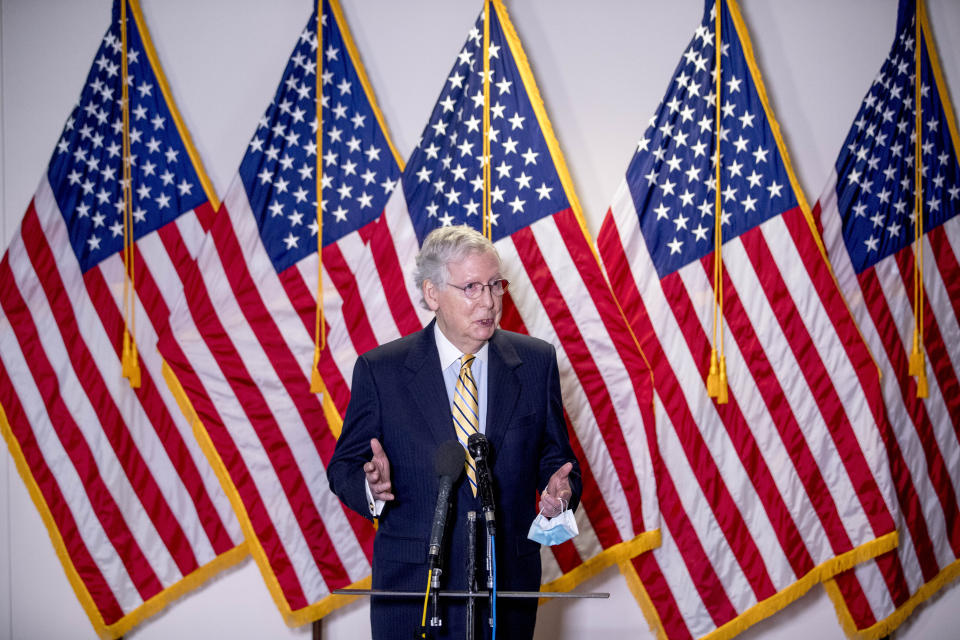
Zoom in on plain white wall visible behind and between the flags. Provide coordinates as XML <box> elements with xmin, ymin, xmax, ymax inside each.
<box><xmin>0</xmin><ymin>0</ymin><xmax>960</xmax><ymax>640</ymax></box>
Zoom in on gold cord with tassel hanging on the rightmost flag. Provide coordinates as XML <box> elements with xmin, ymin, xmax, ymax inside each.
<box><xmin>909</xmin><ymin>0</ymin><xmax>928</xmax><ymax>398</ymax></box>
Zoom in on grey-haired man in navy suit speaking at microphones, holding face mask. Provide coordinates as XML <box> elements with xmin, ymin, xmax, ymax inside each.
<box><xmin>327</xmin><ymin>226</ymin><xmax>581</xmax><ymax>640</ymax></box>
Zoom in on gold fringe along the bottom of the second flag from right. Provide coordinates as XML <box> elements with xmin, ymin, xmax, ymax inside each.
<box><xmin>620</xmin><ymin>531</ymin><xmax>896</xmax><ymax>640</ymax></box>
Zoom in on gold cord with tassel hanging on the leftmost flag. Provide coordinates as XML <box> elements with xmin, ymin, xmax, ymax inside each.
<box><xmin>120</xmin><ymin>0</ymin><xmax>140</xmax><ymax>389</ymax></box>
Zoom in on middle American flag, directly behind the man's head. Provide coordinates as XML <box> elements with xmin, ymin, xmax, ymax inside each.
<box><xmin>382</xmin><ymin>0</ymin><xmax>659</xmax><ymax>589</ymax></box>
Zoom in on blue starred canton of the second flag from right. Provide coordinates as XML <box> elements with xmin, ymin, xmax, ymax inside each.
<box><xmin>627</xmin><ymin>0</ymin><xmax>798</xmax><ymax>278</ymax></box>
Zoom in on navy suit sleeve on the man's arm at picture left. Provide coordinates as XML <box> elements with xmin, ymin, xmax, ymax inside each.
<box><xmin>327</xmin><ymin>356</ymin><xmax>380</xmax><ymax>520</ymax></box>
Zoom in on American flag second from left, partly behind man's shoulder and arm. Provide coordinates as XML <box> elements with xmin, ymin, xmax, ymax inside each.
<box><xmin>160</xmin><ymin>1</ymin><xmax>404</xmax><ymax>625</ymax></box>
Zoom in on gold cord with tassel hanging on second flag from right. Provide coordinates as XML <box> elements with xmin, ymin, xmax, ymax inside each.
<box><xmin>707</xmin><ymin>0</ymin><xmax>729</xmax><ymax>404</ymax></box>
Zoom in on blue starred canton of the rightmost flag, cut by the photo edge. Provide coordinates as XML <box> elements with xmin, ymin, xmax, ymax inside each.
<box><xmin>836</xmin><ymin>3</ymin><xmax>960</xmax><ymax>273</ymax></box>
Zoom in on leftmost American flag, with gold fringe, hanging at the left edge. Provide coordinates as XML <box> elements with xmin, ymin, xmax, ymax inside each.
<box><xmin>0</xmin><ymin>2</ymin><xmax>247</xmax><ymax>637</ymax></box>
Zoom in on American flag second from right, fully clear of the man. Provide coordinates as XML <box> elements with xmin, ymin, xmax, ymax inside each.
<box><xmin>598</xmin><ymin>0</ymin><xmax>896</xmax><ymax>638</ymax></box>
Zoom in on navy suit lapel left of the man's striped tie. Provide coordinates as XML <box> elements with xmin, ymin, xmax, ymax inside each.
<box><xmin>404</xmin><ymin>320</ymin><xmax>456</xmax><ymax>444</ymax></box>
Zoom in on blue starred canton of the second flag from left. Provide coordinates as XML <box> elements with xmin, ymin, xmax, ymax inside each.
<box><xmin>240</xmin><ymin>3</ymin><xmax>400</xmax><ymax>273</ymax></box>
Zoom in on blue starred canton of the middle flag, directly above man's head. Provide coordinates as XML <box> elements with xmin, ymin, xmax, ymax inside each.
<box><xmin>402</xmin><ymin>6</ymin><xmax>570</xmax><ymax>242</ymax></box>
